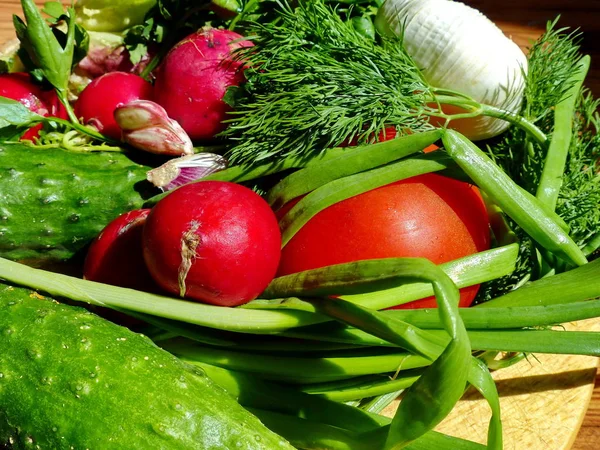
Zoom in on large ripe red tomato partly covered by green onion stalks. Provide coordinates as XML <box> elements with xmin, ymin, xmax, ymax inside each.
<box><xmin>278</xmin><ymin>174</ymin><xmax>490</xmax><ymax>308</ymax></box>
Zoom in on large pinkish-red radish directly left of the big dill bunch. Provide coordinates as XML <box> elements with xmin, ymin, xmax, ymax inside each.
<box><xmin>154</xmin><ymin>28</ymin><xmax>252</xmax><ymax>141</ymax></box>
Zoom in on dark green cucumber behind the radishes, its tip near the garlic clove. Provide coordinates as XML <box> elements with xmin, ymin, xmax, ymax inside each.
<box><xmin>0</xmin><ymin>144</ymin><xmax>156</xmax><ymax>266</ymax></box>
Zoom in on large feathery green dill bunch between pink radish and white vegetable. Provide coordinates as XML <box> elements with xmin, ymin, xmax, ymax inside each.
<box><xmin>224</xmin><ymin>1</ymin><xmax>431</xmax><ymax>163</ymax></box>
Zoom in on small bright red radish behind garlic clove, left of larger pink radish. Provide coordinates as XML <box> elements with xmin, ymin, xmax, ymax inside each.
<box><xmin>75</xmin><ymin>72</ymin><xmax>152</xmax><ymax>139</ymax></box>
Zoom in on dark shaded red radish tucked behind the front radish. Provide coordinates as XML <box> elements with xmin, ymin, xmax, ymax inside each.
<box><xmin>83</xmin><ymin>209</ymin><xmax>158</xmax><ymax>292</ymax></box>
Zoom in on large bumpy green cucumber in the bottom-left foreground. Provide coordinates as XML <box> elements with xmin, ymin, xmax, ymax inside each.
<box><xmin>0</xmin><ymin>285</ymin><xmax>293</xmax><ymax>450</ymax></box>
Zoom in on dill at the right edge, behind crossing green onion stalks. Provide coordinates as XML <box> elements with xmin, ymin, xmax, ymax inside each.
<box><xmin>478</xmin><ymin>21</ymin><xmax>600</xmax><ymax>301</ymax></box>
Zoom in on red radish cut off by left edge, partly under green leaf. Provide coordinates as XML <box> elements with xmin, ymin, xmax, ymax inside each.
<box><xmin>0</xmin><ymin>72</ymin><xmax>50</xmax><ymax>140</ymax></box>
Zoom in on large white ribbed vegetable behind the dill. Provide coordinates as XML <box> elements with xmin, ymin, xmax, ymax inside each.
<box><xmin>375</xmin><ymin>0</ymin><xmax>527</xmax><ymax>140</ymax></box>
